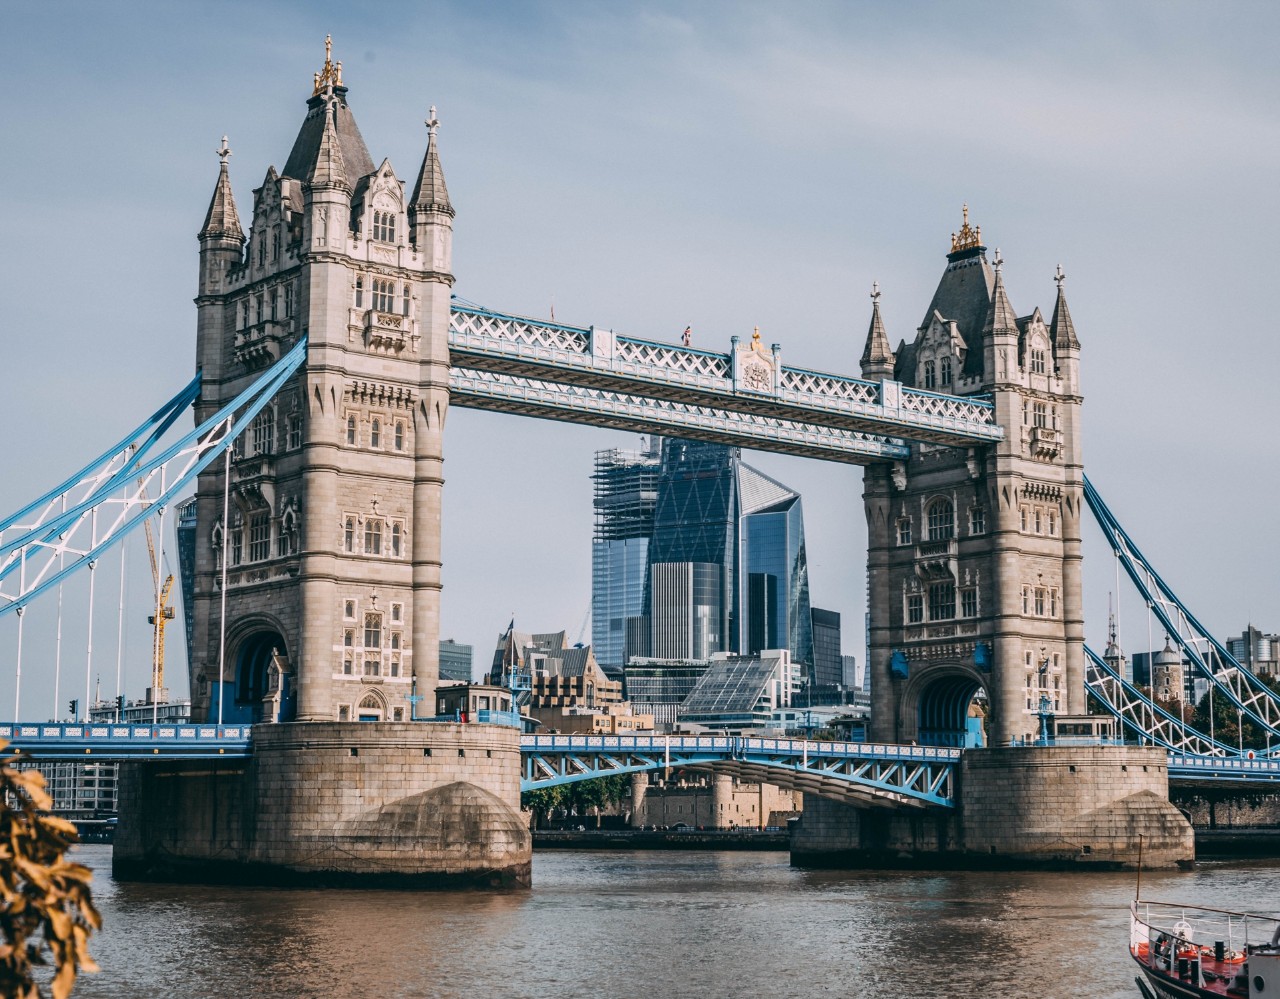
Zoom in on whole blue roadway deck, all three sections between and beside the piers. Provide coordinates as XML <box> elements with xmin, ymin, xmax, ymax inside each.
<box><xmin>0</xmin><ymin>722</ymin><xmax>1280</xmax><ymax>806</ymax></box>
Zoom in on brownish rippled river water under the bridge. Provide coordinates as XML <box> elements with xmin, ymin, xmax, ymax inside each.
<box><xmin>74</xmin><ymin>845</ymin><xmax>1280</xmax><ymax>999</ymax></box>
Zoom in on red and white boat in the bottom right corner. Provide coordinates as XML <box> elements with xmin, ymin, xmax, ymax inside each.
<box><xmin>1129</xmin><ymin>899</ymin><xmax>1280</xmax><ymax>999</ymax></box>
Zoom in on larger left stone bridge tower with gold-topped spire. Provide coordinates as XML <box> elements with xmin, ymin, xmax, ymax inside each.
<box><xmin>191</xmin><ymin>42</ymin><xmax>453</xmax><ymax>721</ymax></box>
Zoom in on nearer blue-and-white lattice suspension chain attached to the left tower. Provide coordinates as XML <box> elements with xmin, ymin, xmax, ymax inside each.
<box><xmin>0</xmin><ymin>337</ymin><xmax>307</xmax><ymax>617</ymax></box>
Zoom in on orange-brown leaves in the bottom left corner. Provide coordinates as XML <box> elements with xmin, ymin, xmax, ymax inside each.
<box><xmin>0</xmin><ymin>740</ymin><xmax>102</xmax><ymax>999</ymax></box>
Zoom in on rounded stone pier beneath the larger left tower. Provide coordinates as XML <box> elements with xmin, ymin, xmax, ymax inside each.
<box><xmin>113</xmin><ymin>722</ymin><xmax>532</xmax><ymax>888</ymax></box>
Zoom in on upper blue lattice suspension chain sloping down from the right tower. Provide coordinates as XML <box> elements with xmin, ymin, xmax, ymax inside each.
<box><xmin>1084</xmin><ymin>478</ymin><xmax>1280</xmax><ymax>754</ymax></box>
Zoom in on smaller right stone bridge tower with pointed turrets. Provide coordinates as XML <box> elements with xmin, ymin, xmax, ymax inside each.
<box><xmin>861</xmin><ymin>209</ymin><xmax>1084</xmax><ymax>745</ymax></box>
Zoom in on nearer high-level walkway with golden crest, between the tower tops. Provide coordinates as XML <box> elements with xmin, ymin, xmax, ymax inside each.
<box><xmin>449</xmin><ymin>306</ymin><xmax>1004</xmax><ymax>446</ymax></box>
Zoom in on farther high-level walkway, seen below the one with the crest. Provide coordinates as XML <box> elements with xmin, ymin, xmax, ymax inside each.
<box><xmin>449</xmin><ymin>368</ymin><xmax>910</xmax><ymax>465</ymax></box>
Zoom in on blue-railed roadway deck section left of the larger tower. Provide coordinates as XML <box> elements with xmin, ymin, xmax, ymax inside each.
<box><xmin>0</xmin><ymin>722</ymin><xmax>251</xmax><ymax>762</ymax></box>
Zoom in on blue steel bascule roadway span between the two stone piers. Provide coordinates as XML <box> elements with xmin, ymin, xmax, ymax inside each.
<box><xmin>520</xmin><ymin>735</ymin><xmax>960</xmax><ymax>808</ymax></box>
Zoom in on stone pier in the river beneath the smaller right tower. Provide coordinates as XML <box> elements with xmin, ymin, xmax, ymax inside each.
<box><xmin>791</xmin><ymin>747</ymin><xmax>1196</xmax><ymax>868</ymax></box>
